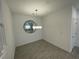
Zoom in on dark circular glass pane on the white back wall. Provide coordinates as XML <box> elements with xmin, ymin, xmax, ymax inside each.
<box><xmin>23</xmin><ymin>20</ymin><xmax>36</xmax><ymax>33</ymax></box>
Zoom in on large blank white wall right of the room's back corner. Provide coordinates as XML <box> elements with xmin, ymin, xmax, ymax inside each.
<box><xmin>43</xmin><ymin>6</ymin><xmax>72</xmax><ymax>52</ymax></box>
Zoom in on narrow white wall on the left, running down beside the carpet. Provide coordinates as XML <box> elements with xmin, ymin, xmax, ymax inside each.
<box><xmin>1</xmin><ymin>0</ymin><xmax>15</xmax><ymax>59</ymax></box>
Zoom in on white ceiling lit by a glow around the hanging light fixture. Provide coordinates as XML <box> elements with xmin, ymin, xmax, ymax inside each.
<box><xmin>8</xmin><ymin>0</ymin><xmax>76</xmax><ymax>16</ymax></box>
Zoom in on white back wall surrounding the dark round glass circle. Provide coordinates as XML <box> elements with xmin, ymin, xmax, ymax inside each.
<box><xmin>13</xmin><ymin>13</ymin><xmax>42</xmax><ymax>46</ymax></box>
